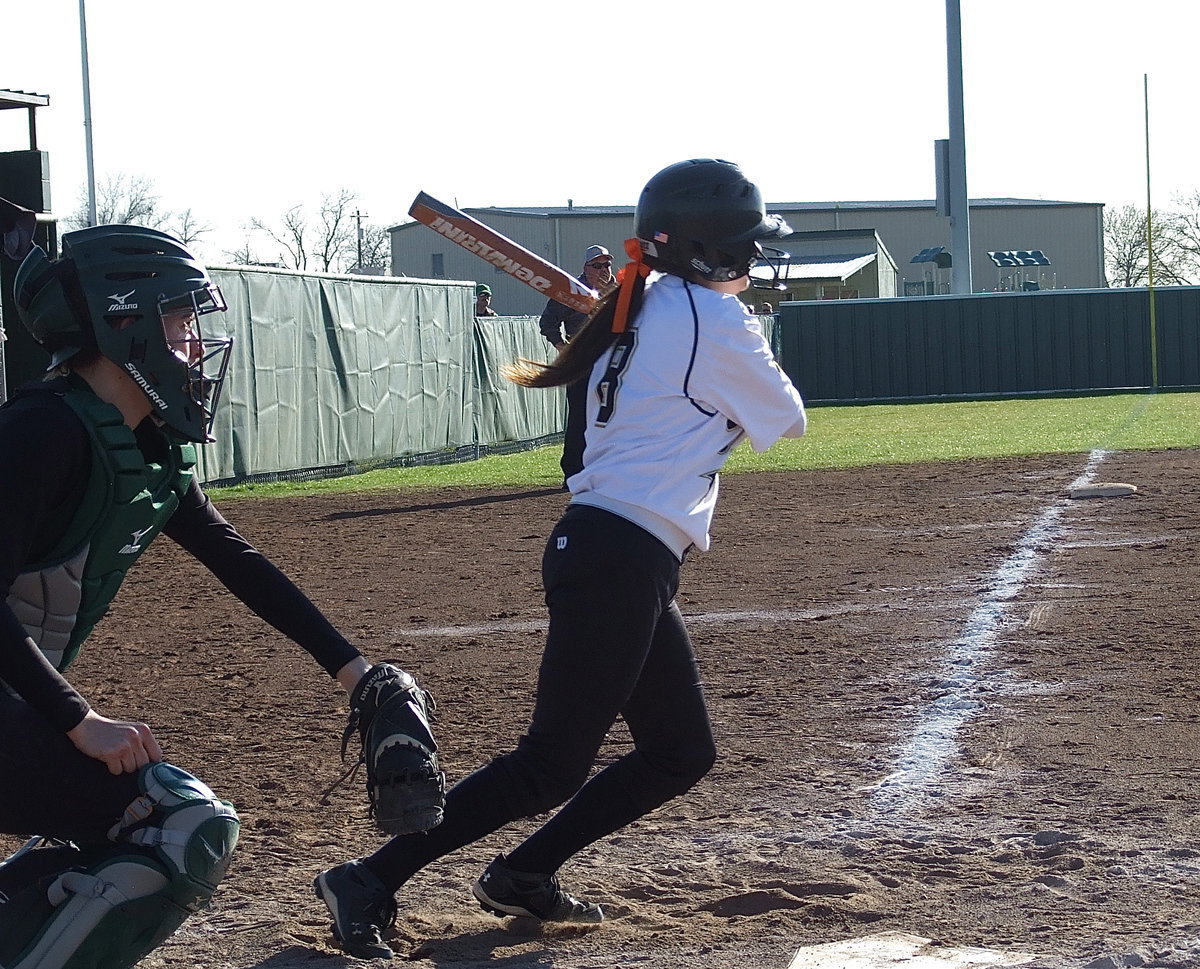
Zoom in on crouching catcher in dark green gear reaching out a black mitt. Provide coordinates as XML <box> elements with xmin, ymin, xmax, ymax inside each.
<box><xmin>0</xmin><ymin>212</ymin><xmax>444</xmax><ymax>969</ymax></box>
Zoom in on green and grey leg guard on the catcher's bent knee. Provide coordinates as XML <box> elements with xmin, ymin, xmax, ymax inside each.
<box><xmin>0</xmin><ymin>764</ymin><xmax>239</xmax><ymax>969</ymax></box>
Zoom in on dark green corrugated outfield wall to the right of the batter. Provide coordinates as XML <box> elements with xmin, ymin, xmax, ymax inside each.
<box><xmin>776</xmin><ymin>287</ymin><xmax>1200</xmax><ymax>403</ymax></box>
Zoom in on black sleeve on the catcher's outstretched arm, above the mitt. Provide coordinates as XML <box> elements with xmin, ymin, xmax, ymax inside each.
<box><xmin>163</xmin><ymin>481</ymin><xmax>361</xmax><ymax>676</ymax></box>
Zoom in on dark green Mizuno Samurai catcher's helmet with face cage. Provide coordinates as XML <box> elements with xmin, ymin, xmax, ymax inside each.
<box><xmin>13</xmin><ymin>225</ymin><xmax>233</xmax><ymax>443</ymax></box>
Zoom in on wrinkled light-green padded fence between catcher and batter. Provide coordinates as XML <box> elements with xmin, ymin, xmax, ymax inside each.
<box><xmin>199</xmin><ymin>269</ymin><xmax>564</xmax><ymax>485</ymax></box>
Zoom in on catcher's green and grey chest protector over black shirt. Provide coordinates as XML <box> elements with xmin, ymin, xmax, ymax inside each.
<box><xmin>8</xmin><ymin>379</ymin><xmax>196</xmax><ymax>672</ymax></box>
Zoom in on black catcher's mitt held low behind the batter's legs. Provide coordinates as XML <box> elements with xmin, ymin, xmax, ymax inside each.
<box><xmin>342</xmin><ymin>663</ymin><xmax>445</xmax><ymax>835</ymax></box>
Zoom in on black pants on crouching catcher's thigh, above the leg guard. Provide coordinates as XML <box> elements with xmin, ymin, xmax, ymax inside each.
<box><xmin>0</xmin><ymin>691</ymin><xmax>140</xmax><ymax>844</ymax></box>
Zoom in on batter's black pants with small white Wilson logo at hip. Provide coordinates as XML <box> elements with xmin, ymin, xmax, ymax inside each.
<box><xmin>366</xmin><ymin>505</ymin><xmax>716</xmax><ymax>891</ymax></box>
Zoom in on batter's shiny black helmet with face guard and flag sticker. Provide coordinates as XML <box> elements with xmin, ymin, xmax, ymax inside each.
<box><xmin>634</xmin><ymin>158</ymin><xmax>792</xmax><ymax>289</ymax></box>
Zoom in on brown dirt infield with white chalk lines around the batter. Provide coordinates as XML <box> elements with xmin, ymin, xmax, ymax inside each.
<box><xmin>5</xmin><ymin>451</ymin><xmax>1200</xmax><ymax>969</ymax></box>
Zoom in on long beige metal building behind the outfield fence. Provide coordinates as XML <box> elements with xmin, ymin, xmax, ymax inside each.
<box><xmin>389</xmin><ymin>198</ymin><xmax>1105</xmax><ymax>315</ymax></box>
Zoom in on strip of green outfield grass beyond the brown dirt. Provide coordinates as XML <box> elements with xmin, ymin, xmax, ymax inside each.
<box><xmin>212</xmin><ymin>393</ymin><xmax>1200</xmax><ymax>500</ymax></box>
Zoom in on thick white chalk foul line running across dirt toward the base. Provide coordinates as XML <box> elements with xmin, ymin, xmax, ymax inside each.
<box><xmin>866</xmin><ymin>450</ymin><xmax>1109</xmax><ymax>813</ymax></box>
